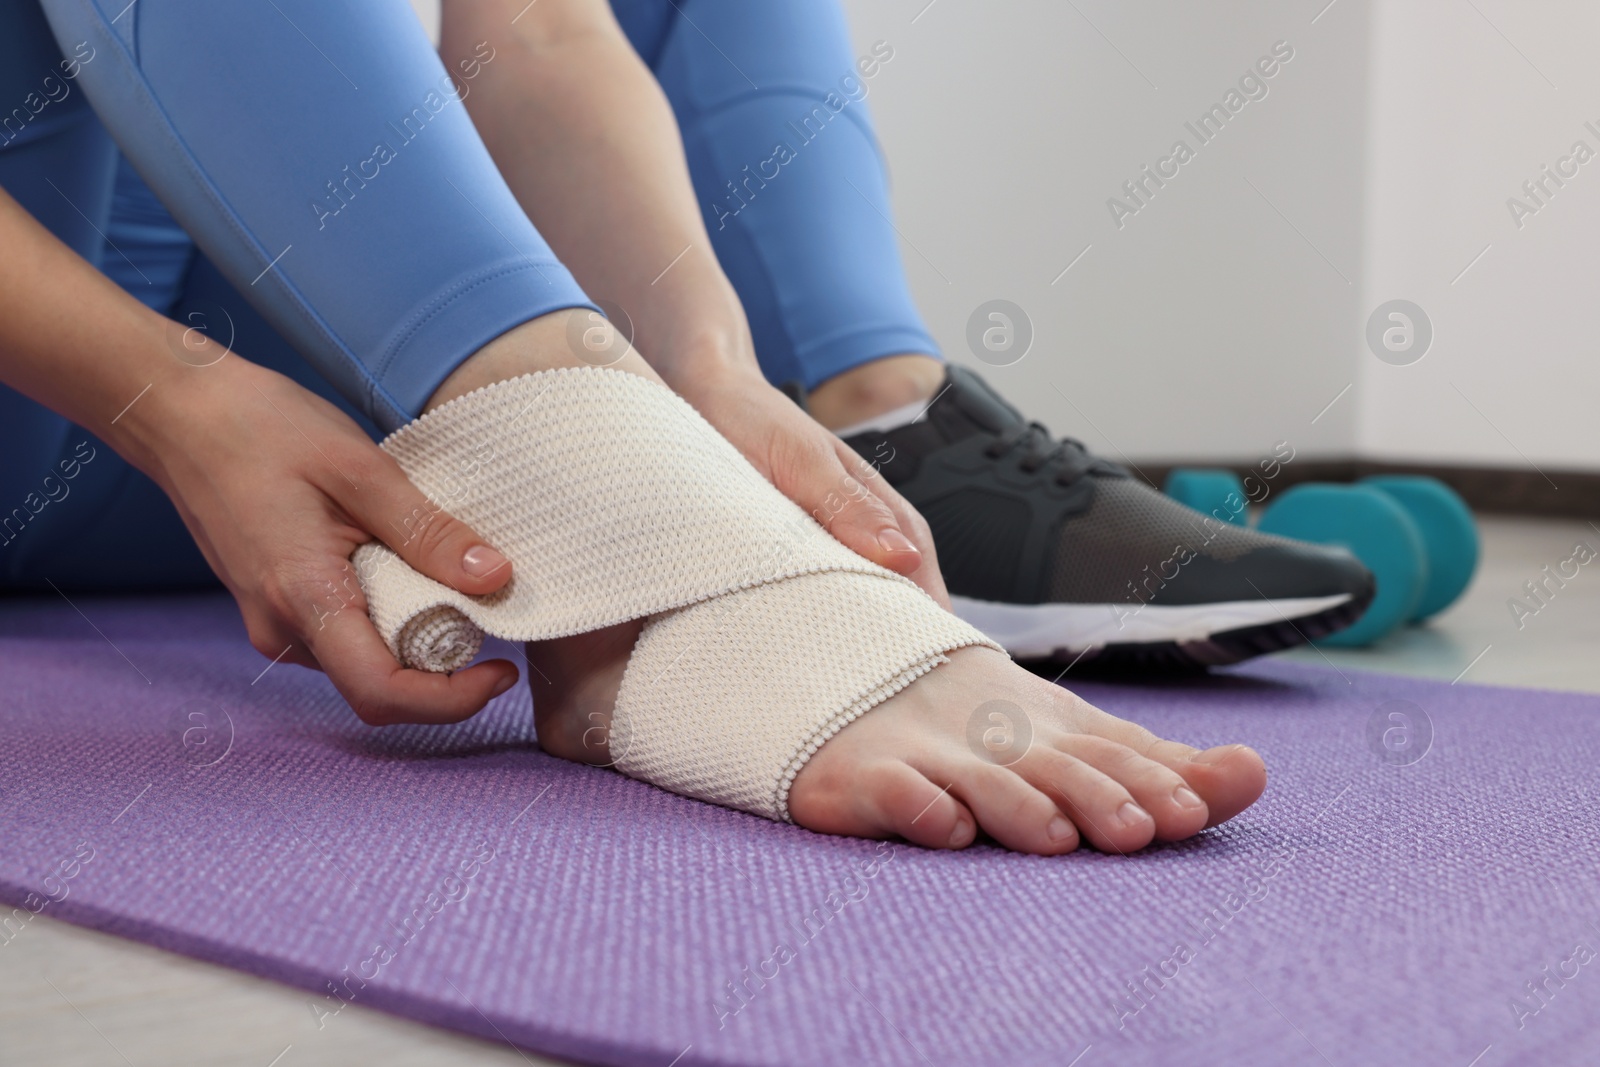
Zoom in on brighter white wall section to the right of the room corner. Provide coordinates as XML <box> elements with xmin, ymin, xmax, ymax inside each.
<box><xmin>1357</xmin><ymin>0</ymin><xmax>1600</xmax><ymax>469</ymax></box>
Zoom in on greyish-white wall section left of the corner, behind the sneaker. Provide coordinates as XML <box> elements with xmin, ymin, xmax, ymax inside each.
<box><xmin>846</xmin><ymin>0</ymin><xmax>1368</xmax><ymax>459</ymax></box>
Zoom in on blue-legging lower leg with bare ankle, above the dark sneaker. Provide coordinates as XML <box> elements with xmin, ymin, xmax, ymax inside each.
<box><xmin>613</xmin><ymin>0</ymin><xmax>942</xmax><ymax>426</ymax></box>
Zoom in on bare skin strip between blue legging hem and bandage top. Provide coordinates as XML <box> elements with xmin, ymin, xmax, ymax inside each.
<box><xmin>422</xmin><ymin>307</ymin><xmax>656</xmax><ymax>411</ymax></box>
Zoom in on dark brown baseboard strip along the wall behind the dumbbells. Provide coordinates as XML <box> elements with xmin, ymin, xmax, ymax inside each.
<box><xmin>1138</xmin><ymin>458</ymin><xmax>1600</xmax><ymax>518</ymax></box>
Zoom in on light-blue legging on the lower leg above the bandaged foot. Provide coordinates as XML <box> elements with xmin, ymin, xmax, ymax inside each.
<box><xmin>43</xmin><ymin>0</ymin><xmax>601</xmax><ymax>429</ymax></box>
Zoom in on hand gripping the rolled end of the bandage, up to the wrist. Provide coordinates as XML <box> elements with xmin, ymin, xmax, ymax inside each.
<box><xmin>128</xmin><ymin>355</ymin><xmax>517</xmax><ymax>726</ymax></box>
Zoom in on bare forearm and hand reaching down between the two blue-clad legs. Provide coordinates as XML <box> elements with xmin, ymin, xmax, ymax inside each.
<box><xmin>440</xmin><ymin>0</ymin><xmax>949</xmax><ymax>606</ymax></box>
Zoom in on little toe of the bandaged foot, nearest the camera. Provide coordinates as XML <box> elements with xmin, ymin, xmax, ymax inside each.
<box><xmin>789</xmin><ymin>749</ymin><xmax>978</xmax><ymax>848</ymax></box>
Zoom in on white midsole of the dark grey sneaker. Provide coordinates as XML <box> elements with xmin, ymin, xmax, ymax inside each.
<box><xmin>950</xmin><ymin>593</ymin><xmax>1350</xmax><ymax>659</ymax></box>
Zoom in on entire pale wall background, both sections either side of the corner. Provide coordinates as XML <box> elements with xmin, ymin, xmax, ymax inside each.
<box><xmin>846</xmin><ymin>0</ymin><xmax>1600</xmax><ymax>469</ymax></box>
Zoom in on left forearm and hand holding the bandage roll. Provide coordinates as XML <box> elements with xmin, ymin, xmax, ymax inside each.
<box><xmin>0</xmin><ymin>189</ymin><xmax>517</xmax><ymax>725</ymax></box>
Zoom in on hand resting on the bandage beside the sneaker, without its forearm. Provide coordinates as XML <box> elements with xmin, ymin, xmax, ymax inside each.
<box><xmin>669</xmin><ymin>357</ymin><xmax>950</xmax><ymax>609</ymax></box>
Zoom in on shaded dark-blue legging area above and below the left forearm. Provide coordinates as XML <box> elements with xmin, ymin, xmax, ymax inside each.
<box><xmin>0</xmin><ymin>5</ymin><xmax>380</xmax><ymax>592</ymax></box>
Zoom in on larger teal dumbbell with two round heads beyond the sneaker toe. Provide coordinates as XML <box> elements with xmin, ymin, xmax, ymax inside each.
<box><xmin>1259</xmin><ymin>475</ymin><xmax>1478</xmax><ymax>646</ymax></box>
